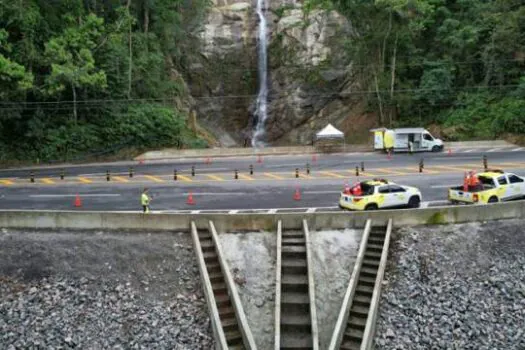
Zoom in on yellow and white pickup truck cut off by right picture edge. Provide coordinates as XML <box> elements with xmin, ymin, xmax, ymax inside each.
<box><xmin>448</xmin><ymin>170</ymin><xmax>525</xmax><ymax>204</ymax></box>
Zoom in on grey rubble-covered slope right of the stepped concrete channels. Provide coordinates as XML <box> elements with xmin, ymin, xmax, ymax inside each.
<box><xmin>375</xmin><ymin>220</ymin><xmax>525</xmax><ymax>350</ymax></box>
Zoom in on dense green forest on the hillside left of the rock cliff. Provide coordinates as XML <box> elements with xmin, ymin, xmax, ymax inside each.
<box><xmin>0</xmin><ymin>0</ymin><xmax>207</xmax><ymax>161</ymax></box>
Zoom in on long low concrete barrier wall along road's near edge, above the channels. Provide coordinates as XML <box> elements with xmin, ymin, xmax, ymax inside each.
<box><xmin>0</xmin><ymin>201</ymin><xmax>525</xmax><ymax>232</ymax></box>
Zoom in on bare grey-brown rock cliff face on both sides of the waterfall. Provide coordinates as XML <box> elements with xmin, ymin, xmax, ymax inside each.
<box><xmin>187</xmin><ymin>0</ymin><xmax>366</xmax><ymax>146</ymax></box>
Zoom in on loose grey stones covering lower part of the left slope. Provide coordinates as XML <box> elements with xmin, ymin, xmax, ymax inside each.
<box><xmin>0</xmin><ymin>278</ymin><xmax>212</xmax><ymax>349</ymax></box>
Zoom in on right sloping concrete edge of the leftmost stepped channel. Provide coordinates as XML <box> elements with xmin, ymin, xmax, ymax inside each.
<box><xmin>208</xmin><ymin>220</ymin><xmax>257</xmax><ymax>350</ymax></box>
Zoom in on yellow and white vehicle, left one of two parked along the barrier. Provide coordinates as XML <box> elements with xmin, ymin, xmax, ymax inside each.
<box><xmin>339</xmin><ymin>179</ymin><xmax>423</xmax><ymax>210</ymax></box>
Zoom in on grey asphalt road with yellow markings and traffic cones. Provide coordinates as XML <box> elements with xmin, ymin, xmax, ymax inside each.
<box><xmin>0</xmin><ymin>147</ymin><xmax>525</xmax><ymax>212</ymax></box>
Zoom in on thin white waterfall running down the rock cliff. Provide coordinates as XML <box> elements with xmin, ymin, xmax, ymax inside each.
<box><xmin>252</xmin><ymin>0</ymin><xmax>268</xmax><ymax>147</ymax></box>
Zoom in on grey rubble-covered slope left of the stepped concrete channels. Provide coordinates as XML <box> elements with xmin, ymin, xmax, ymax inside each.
<box><xmin>0</xmin><ymin>230</ymin><xmax>213</xmax><ymax>349</ymax></box>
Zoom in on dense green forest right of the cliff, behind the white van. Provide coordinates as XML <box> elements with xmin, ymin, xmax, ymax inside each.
<box><xmin>307</xmin><ymin>0</ymin><xmax>525</xmax><ymax>139</ymax></box>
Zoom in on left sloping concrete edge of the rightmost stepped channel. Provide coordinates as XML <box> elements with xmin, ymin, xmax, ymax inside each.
<box><xmin>328</xmin><ymin>219</ymin><xmax>372</xmax><ymax>350</ymax></box>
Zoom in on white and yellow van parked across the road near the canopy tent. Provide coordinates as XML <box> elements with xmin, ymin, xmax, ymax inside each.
<box><xmin>370</xmin><ymin>128</ymin><xmax>444</xmax><ymax>152</ymax></box>
